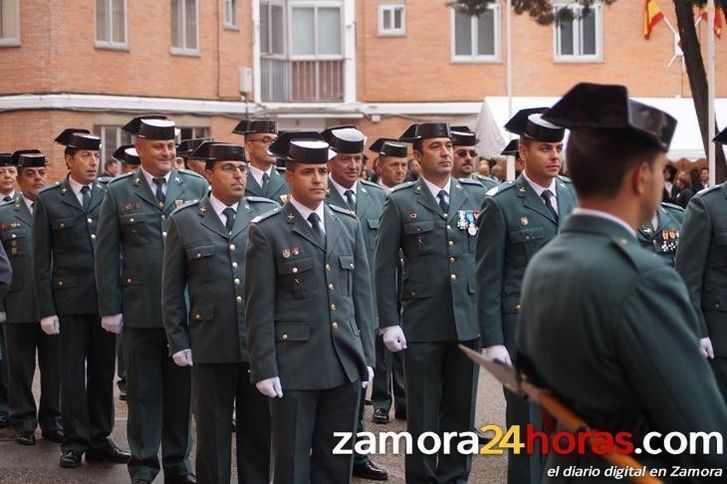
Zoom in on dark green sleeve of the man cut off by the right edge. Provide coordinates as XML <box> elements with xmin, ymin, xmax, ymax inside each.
<box><xmin>675</xmin><ymin>197</ymin><xmax>712</xmax><ymax>338</ymax></box>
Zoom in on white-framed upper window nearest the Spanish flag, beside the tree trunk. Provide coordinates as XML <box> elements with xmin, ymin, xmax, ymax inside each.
<box><xmin>554</xmin><ymin>4</ymin><xmax>603</xmax><ymax>62</ymax></box>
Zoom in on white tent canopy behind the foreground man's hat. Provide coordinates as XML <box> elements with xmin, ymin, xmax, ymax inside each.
<box><xmin>477</xmin><ymin>96</ymin><xmax>727</xmax><ymax>161</ymax></box>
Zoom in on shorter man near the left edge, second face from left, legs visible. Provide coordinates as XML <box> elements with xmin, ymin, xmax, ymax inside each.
<box><xmin>0</xmin><ymin>153</ymin><xmax>63</xmax><ymax>445</ymax></box>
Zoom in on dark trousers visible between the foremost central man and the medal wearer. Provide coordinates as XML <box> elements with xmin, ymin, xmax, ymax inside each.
<box><xmin>371</xmin><ymin>335</ymin><xmax>406</xmax><ymax>413</ymax></box>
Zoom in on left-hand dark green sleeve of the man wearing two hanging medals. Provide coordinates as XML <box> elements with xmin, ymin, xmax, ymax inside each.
<box><xmin>374</xmin><ymin>196</ymin><xmax>401</xmax><ymax>328</ymax></box>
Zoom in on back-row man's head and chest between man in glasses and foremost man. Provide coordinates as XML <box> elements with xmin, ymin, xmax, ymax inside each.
<box><xmin>232</xmin><ymin>119</ymin><xmax>290</xmax><ymax>203</ymax></box>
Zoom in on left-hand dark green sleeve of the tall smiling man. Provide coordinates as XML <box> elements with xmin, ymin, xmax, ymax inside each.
<box><xmin>96</xmin><ymin>183</ymin><xmax>123</xmax><ymax>317</ymax></box>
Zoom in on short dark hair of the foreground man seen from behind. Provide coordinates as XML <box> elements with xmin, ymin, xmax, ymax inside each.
<box><xmin>565</xmin><ymin>128</ymin><xmax>662</xmax><ymax>197</ymax></box>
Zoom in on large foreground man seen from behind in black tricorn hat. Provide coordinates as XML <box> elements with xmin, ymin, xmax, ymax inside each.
<box><xmin>517</xmin><ymin>83</ymin><xmax>727</xmax><ymax>483</ymax></box>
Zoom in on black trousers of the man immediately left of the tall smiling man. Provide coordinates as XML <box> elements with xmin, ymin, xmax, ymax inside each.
<box><xmin>59</xmin><ymin>314</ymin><xmax>114</xmax><ymax>452</ymax></box>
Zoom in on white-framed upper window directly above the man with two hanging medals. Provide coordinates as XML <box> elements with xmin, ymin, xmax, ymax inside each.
<box><xmin>452</xmin><ymin>4</ymin><xmax>500</xmax><ymax>62</ymax></box>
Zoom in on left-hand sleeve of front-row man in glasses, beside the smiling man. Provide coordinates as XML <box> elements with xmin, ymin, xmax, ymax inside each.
<box><xmin>162</xmin><ymin>215</ymin><xmax>192</xmax><ymax>355</ymax></box>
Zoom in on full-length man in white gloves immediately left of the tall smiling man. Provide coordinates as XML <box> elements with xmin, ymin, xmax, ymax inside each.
<box><xmin>33</xmin><ymin>129</ymin><xmax>129</xmax><ymax>467</ymax></box>
